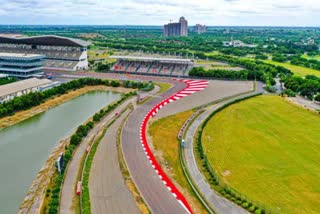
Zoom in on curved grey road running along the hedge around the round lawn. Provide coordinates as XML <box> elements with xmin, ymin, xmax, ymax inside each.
<box><xmin>184</xmin><ymin>83</ymin><xmax>263</xmax><ymax>214</ymax></box>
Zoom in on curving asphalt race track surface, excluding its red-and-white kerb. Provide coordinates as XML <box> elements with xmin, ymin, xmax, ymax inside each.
<box><xmin>121</xmin><ymin>81</ymin><xmax>186</xmax><ymax>214</ymax></box>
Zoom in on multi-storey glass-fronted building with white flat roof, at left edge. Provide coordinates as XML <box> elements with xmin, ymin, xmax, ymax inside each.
<box><xmin>0</xmin><ymin>53</ymin><xmax>45</xmax><ymax>79</ymax></box>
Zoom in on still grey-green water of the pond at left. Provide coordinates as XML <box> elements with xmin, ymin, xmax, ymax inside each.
<box><xmin>0</xmin><ymin>91</ymin><xmax>120</xmax><ymax>213</ymax></box>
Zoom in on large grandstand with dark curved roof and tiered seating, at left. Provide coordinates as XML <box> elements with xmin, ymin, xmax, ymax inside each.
<box><xmin>0</xmin><ymin>35</ymin><xmax>89</xmax><ymax>71</ymax></box>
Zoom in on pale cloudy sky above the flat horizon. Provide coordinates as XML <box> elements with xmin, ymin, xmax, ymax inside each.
<box><xmin>0</xmin><ymin>0</ymin><xmax>320</xmax><ymax>27</ymax></box>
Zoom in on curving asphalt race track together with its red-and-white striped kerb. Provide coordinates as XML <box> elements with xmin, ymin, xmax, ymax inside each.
<box><xmin>122</xmin><ymin>80</ymin><xmax>207</xmax><ymax>213</ymax></box>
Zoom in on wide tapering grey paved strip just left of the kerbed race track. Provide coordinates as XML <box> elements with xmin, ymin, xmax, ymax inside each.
<box><xmin>89</xmin><ymin>110</ymin><xmax>139</xmax><ymax>214</ymax></box>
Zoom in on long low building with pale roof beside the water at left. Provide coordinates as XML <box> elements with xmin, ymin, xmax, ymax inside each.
<box><xmin>0</xmin><ymin>78</ymin><xmax>57</xmax><ymax>103</ymax></box>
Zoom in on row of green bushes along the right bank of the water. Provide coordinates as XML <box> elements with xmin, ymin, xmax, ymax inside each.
<box><xmin>46</xmin><ymin>92</ymin><xmax>136</xmax><ymax>214</ymax></box>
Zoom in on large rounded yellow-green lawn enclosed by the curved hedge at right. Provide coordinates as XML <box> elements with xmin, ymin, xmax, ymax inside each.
<box><xmin>202</xmin><ymin>95</ymin><xmax>320</xmax><ymax>214</ymax></box>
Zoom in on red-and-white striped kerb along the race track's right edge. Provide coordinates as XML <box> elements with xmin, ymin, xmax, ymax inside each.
<box><xmin>140</xmin><ymin>80</ymin><xmax>208</xmax><ymax>213</ymax></box>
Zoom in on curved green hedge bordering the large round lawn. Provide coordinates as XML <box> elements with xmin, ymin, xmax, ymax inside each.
<box><xmin>196</xmin><ymin>94</ymin><xmax>270</xmax><ymax>214</ymax></box>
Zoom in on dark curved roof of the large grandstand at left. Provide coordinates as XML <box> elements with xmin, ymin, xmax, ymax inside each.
<box><xmin>0</xmin><ymin>35</ymin><xmax>89</xmax><ymax>47</ymax></box>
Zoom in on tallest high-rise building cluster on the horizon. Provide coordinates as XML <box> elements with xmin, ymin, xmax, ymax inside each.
<box><xmin>163</xmin><ymin>17</ymin><xmax>188</xmax><ymax>37</ymax></box>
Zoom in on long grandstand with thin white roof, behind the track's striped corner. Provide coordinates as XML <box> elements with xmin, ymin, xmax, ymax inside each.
<box><xmin>110</xmin><ymin>56</ymin><xmax>194</xmax><ymax>76</ymax></box>
